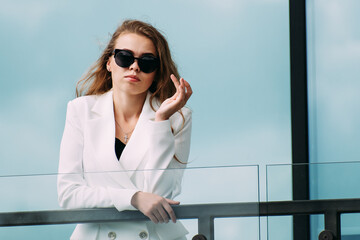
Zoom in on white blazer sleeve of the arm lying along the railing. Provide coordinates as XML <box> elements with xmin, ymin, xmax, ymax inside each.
<box><xmin>57</xmin><ymin>101</ymin><xmax>138</xmax><ymax>211</ymax></box>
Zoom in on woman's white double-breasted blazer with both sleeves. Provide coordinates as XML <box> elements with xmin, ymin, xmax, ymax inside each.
<box><xmin>58</xmin><ymin>90</ymin><xmax>191</xmax><ymax>240</ymax></box>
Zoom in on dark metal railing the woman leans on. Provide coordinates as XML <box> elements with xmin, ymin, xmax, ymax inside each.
<box><xmin>0</xmin><ymin>199</ymin><xmax>360</xmax><ymax>240</ymax></box>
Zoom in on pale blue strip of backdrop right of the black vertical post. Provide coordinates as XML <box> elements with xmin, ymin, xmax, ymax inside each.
<box><xmin>307</xmin><ymin>0</ymin><xmax>360</xmax><ymax>236</ymax></box>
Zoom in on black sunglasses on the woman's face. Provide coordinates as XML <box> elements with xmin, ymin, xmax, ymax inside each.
<box><xmin>114</xmin><ymin>49</ymin><xmax>160</xmax><ymax>73</ymax></box>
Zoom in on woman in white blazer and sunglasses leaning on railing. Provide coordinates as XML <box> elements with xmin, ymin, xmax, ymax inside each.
<box><xmin>58</xmin><ymin>20</ymin><xmax>192</xmax><ymax>240</ymax></box>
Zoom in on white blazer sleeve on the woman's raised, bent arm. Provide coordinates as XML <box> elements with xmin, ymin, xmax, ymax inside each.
<box><xmin>144</xmin><ymin>107</ymin><xmax>192</xmax><ymax>199</ymax></box>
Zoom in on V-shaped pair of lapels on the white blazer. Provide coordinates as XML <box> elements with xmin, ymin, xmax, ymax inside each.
<box><xmin>86</xmin><ymin>90</ymin><xmax>155</xmax><ymax>186</ymax></box>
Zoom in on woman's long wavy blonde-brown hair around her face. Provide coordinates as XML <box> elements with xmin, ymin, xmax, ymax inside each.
<box><xmin>76</xmin><ymin>20</ymin><xmax>180</xmax><ymax>108</ymax></box>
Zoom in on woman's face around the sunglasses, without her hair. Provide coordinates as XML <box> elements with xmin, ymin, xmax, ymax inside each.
<box><xmin>107</xmin><ymin>33</ymin><xmax>156</xmax><ymax>95</ymax></box>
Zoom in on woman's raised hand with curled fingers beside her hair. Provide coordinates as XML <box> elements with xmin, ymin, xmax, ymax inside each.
<box><xmin>155</xmin><ymin>74</ymin><xmax>192</xmax><ymax>121</ymax></box>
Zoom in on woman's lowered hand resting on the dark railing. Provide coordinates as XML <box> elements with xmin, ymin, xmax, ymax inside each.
<box><xmin>131</xmin><ymin>192</ymin><xmax>180</xmax><ymax>223</ymax></box>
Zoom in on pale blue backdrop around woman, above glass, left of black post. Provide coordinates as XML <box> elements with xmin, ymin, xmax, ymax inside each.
<box><xmin>0</xmin><ymin>0</ymin><xmax>291</xmax><ymax>238</ymax></box>
